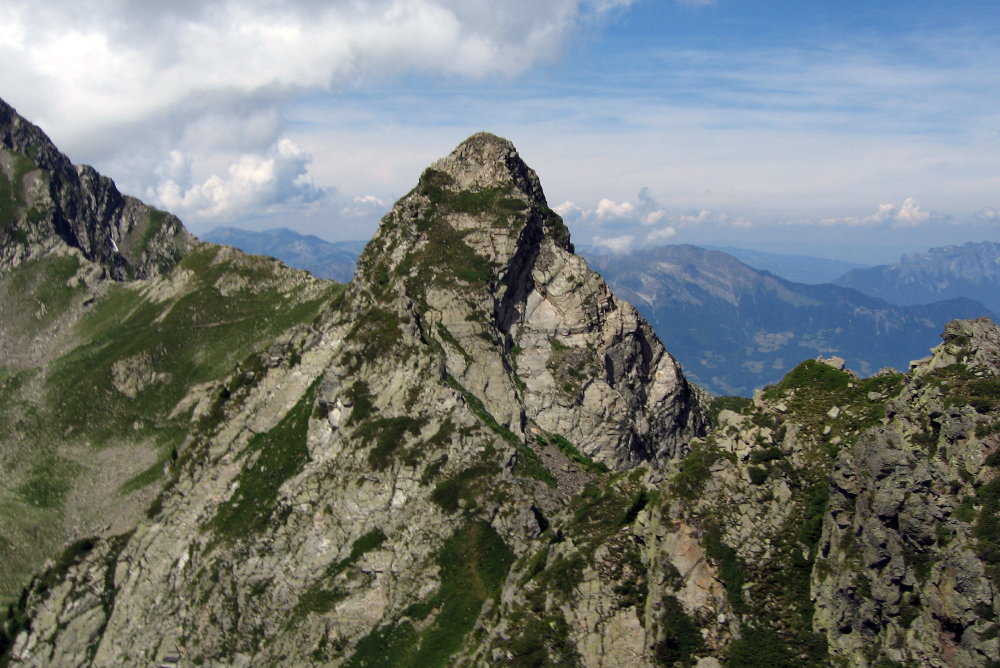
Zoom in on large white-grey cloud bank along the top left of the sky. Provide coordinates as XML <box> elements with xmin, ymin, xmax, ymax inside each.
<box><xmin>0</xmin><ymin>0</ymin><xmax>630</xmax><ymax>140</ymax></box>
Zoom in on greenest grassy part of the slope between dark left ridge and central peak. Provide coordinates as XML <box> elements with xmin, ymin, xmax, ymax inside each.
<box><xmin>46</xmin><ymin>248</ymin><xmax>343</xmax><ymax>446</ymax></box>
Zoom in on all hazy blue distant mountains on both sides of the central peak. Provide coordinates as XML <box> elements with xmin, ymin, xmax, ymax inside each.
<box><xmin>199</xmin><ymin>228</ymin><xmax>1000</xmax><ymax>395</ymax></box>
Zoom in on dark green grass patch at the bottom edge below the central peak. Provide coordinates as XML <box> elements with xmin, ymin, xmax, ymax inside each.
<box><xmin>346</xmin><ymin>521</ymin><xmax>514</xmax><ymax>668</ymax></box>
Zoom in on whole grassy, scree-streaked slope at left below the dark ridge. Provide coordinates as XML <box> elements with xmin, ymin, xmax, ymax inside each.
<box><xmin>0</xmin><ymin>246</ymin><xmax>343</xmax><ymax>603</ymax></box>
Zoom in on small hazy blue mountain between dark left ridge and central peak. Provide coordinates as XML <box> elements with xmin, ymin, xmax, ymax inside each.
<box><xmin>203</xmin><ymin>227</ymin><xmax>365</xmax><ymax>283</ymax></box>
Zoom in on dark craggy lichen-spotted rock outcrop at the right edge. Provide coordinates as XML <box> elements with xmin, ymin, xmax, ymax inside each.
<box><xmin>813</xmin><ymin>319</ymin><xmax>1000</xmax><ymax>666</ymax></box>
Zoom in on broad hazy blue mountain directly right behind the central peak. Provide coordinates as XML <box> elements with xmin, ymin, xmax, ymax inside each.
<box><xmin>585</xmin><ymin>245</ymin><xmax>991</xmax><ymax>395</ymax></box>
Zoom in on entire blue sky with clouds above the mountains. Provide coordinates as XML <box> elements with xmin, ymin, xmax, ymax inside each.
<box><xmin>0</xmin><ymin>0</ymin><xmax>1000</xmax><ymax>264</ymax></box>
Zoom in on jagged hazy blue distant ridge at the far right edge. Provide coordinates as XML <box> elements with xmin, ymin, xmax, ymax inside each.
<box><xmin>834</xmin><ymin>241</ymin><xmax>1000</xmax><ymax>311</ymax></box>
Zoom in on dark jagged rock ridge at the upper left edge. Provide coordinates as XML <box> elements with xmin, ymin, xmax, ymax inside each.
<box><xmin>0</xmin><ymin>100</ymin><xmax>193</xmax><ymax>280</ymax></box>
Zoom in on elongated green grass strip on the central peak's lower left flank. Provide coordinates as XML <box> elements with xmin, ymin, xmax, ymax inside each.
<box><xmin>209</xmin><ymin>384</ymin><xmax>316</xmax><ymax>542</ymax></box>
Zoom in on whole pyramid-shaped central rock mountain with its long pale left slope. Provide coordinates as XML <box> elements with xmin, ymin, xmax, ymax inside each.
<box><xmin>3</xmin><ymin>135</ymin><xmax>703</xmax><ymax>666</ymax></box>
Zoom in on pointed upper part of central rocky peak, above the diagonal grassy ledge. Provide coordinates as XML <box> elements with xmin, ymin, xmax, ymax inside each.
<box><xmin>345</xmin><ymin>133</ymin><xmax>703</xmax><ymax>469</ymax></box>
